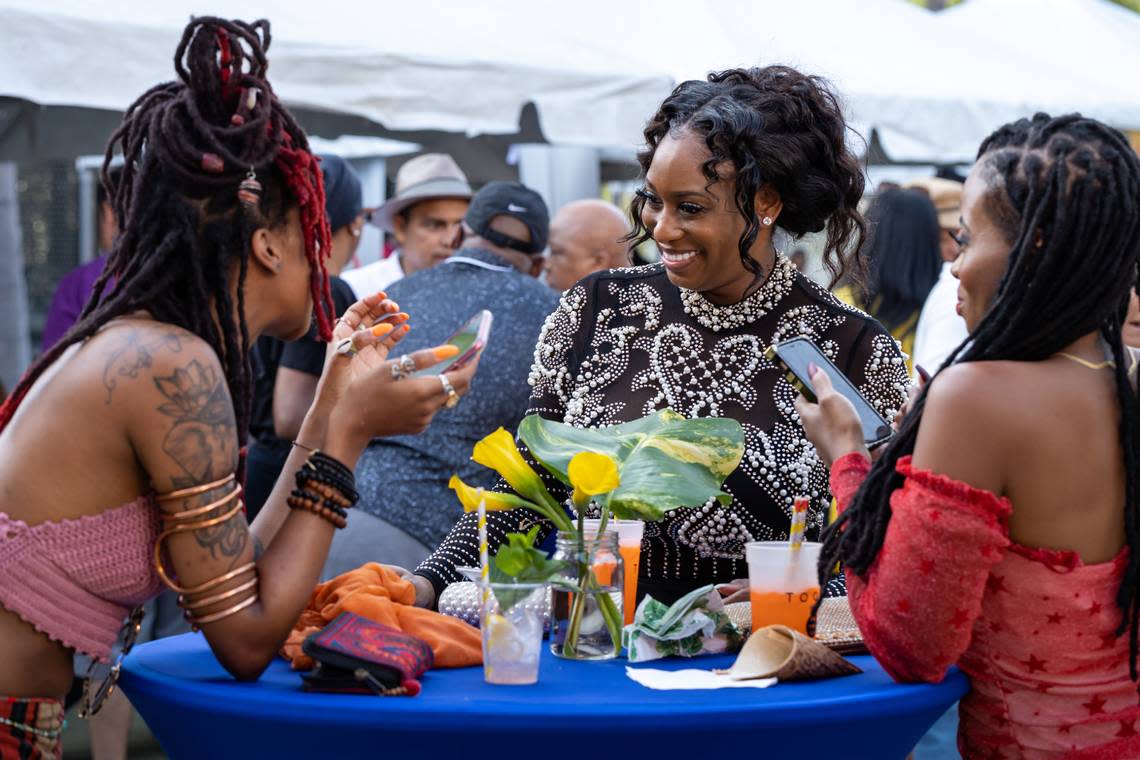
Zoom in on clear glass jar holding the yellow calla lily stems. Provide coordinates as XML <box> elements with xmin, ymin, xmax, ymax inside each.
<box><xmin>551</xmin><ymin>530</ymin><xmax>624</xmax><ymax>660</ymax></box>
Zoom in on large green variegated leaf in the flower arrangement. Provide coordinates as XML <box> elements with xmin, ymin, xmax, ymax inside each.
<box><xmin>519</xmin><ymin>409</ymin><xmax>744</xmax><ymax>521</ymax></box>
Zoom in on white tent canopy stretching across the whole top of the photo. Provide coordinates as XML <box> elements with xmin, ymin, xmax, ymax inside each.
<box><xmin>0</xmin><ymin>0</ymin><xmax>1140</xmax><ymax>162</ymax></box>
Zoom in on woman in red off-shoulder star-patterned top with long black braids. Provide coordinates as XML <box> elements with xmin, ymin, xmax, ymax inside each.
<box><xmin>796</xmin><ymin>114</ymin><xmax>1140</xmax><ymax>760</ymax></box>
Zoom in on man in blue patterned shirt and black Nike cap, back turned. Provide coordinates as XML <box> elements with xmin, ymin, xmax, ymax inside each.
<box><xmin>324</xmin><ymin>182</ymin><xmax>559</xmax><ymax>578</ymax></box>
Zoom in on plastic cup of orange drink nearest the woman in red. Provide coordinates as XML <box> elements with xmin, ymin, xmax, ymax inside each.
<box><xmin>744</xmin><ymin>541</ymin><xmax>822</xmax><ymax>634</ymax></box>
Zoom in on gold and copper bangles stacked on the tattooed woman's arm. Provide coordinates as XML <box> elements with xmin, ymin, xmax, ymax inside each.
<box><xmin>154</xmin><ymin>475</ymin><xmax>258</xmax><ymax>630</ymax></box>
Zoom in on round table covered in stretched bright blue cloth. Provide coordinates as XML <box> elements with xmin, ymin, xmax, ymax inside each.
<box><xmin>120</xmin><ymin>634</ymin><xmax>967</xmax><ymax>760</ymax></box>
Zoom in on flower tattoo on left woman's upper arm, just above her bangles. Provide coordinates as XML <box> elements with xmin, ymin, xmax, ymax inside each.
<box><xmin>154</xmin><ymin>359</ymin><xmax>237</xmax><ymax>488</ymax></box>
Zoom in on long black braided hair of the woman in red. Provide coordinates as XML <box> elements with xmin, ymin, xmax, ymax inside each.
<box><xmin>820</xmin><ymin>114</ymin><xmax>1140</xmax><ymax>680</ymax></box>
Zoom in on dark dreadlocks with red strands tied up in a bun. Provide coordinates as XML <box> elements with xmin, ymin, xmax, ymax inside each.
<box><xmin>0</xmin><ymin>17</ymin><xmax>333</xmax><ymax>439</ymax></box>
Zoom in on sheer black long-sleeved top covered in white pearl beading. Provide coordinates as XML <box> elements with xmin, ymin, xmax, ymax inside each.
<box><xmin>416</xmin><ymin>255</ymin><xmax>910</xmax><ymax>594</ymax></box>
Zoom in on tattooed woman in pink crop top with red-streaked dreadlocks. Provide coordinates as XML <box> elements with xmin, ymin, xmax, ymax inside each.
<box><xmin>0</xmin><ymin>18</ymin><xmax>474</xmax><ymax>758</ymax></box>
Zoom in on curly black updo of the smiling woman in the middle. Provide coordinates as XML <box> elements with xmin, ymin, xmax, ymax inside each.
<box><xmin>629</xmin><ymin>66</ymin><xmax>866</xmax><ymax>289</ymax></box>
